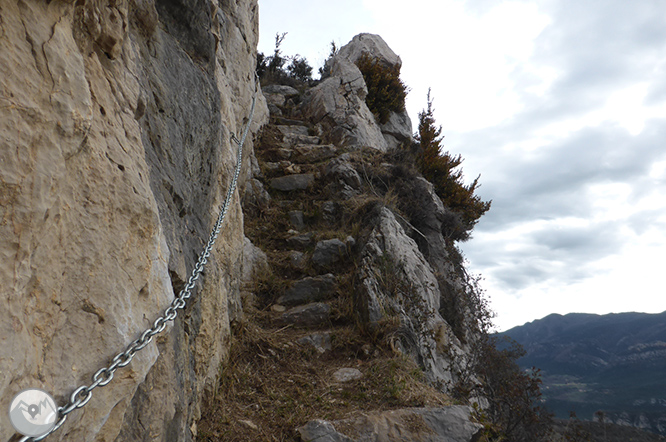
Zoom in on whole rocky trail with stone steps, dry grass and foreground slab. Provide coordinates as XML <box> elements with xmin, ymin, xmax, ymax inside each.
<box><xmin>197</xmin><ymin>86</ymin><xmax>478</xmax><ymax>441</ymax></box>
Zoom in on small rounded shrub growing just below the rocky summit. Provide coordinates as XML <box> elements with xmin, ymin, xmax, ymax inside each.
<box><xmin>356</xmin><ymin>54</ymin><xmax>407</xmax><ymax>124</ymax></box>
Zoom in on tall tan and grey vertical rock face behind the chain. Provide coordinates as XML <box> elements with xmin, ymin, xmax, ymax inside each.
<box><xmin>0</xmin><ymin>0</ymin><xmax>267</xmax><ymax>441</ymax></box>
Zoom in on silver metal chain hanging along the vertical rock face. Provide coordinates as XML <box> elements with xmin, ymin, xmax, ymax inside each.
<box><xmin>19</xmin><ymin>73</ymin><xmax>259</xmax><ymax>442</ymax></box>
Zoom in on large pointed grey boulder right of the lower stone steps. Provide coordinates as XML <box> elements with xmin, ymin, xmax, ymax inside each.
<box><xmin>359</xmin><ymin>208</ymin><xmax>460</xmax><ymax>382</ymax></box>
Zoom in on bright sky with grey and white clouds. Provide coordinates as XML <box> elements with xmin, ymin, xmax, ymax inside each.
<box><xmin>259</xmin><ymin>0</ymin><xmax>666</xmax><ymax>330</ymax></box>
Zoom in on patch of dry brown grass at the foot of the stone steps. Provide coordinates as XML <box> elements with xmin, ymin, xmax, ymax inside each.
<box><xmin>197</xmin><ymin>321</ymin><xmax>450</xmax><ymax>442</ymax></box>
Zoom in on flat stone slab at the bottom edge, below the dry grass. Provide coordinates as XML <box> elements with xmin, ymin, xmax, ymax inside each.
<box><xmin>298</xmin><ymin>405</ymin><xmax>483</xmax><ymax>442</ymax></box>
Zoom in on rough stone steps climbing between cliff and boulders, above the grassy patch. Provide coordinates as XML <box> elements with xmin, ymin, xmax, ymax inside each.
<box><xmin>248</xmin><ymin>95</ymin><xmax>356</xmax><ymax>358</ymax></box>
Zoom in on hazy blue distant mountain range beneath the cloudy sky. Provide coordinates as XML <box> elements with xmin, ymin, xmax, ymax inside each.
<box><xmin>499</xmin><ymin>312</ymin><xmax>666</xmax><ymax>435</ymax></box>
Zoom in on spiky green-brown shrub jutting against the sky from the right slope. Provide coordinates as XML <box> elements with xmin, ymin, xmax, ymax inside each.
<box><xmin>415</xmin><ymin>91</ymin><xmax>491</xmax><ymax>241</ymax></box>
